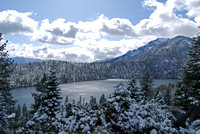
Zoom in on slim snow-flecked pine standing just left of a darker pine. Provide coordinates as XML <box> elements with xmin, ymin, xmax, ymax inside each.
<box><xmin>127</xmin><ymin>74</ymin><xmax>143</xmax><ymax>102</ymax></box>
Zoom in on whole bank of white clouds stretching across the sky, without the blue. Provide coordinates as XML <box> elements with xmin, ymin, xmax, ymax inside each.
<box><xmin>0</xmin><ymin>0</ymin><xmax>200</xmax><ymax>62</ymax></box>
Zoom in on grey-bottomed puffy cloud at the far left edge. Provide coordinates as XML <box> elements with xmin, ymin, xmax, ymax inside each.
<box><xmin>0</xmin><ymin>10</ymin><xmax>38</xmax><ymax>34</ymax></box>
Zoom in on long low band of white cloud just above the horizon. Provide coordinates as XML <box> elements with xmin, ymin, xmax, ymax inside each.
<box><xmin>7</xmin><ymin>38</ymin><xmax>152</xmax><ymax>62</ymax></box>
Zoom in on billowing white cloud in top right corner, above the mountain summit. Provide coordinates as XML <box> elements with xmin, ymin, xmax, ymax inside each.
<box><xmin>134</xmin><ymin>0</ymin><xmax>198</xmax><ymax>37</ymax></box>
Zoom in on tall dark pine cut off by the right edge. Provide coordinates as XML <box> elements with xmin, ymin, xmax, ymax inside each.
<box><xmin>176</xmin><ymin>35</ymin><xmax>200</xmax><ymax>120</ymax></box>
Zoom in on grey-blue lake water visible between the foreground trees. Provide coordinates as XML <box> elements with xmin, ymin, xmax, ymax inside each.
<box><xmin>12</xmin><ymin>79</ymin><xmax>177</xmax><ymax>107</ymax></box>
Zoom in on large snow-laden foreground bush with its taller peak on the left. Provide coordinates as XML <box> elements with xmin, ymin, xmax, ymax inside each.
<box><xmin>104</xmin><ymin>81</ymin><xmax>177</xmax><ymax>133</ymax></box>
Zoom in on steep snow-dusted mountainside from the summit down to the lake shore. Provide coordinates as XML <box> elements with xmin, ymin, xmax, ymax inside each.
<box><xmin>106</xmin><ymin>36</ymin><xmax>193</xmax><ymax>78</ymax></box>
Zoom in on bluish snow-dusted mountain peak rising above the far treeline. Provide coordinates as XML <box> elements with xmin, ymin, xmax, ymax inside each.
<box><xmin>110</xmin><ymin>36</ymin><xmax>193</xmax><ymax>62</ymax></box>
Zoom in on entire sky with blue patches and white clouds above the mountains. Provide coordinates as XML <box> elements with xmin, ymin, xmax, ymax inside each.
<box><xmin>0</xmin><ymin>0</ymin><xmax>200</xmax><ymax>62</ymax></box>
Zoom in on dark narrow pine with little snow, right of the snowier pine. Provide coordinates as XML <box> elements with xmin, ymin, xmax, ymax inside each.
<box><xmin>140</xmin><ymin>72</ymin><xmax>153</xmax><ymax>101</ymax></box>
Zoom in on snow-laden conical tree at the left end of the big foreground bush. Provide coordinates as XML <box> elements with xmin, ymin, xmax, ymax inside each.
<box><xmin>104</xmin><ymin>83</ymin><xmax>132</xmax><ymax>133</ymax></box>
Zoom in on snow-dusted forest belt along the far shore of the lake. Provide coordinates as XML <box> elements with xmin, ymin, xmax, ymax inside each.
<box><xmin>12</xmin><ymin>60</ymin><xmax>182</xmax><ymax>87</ymax></box>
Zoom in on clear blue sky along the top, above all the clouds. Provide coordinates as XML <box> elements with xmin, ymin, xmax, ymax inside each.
<box><xmin>1</xmin><ymin>0</ymin><xmax>151</xmax><ymax>24</ymax></box>
